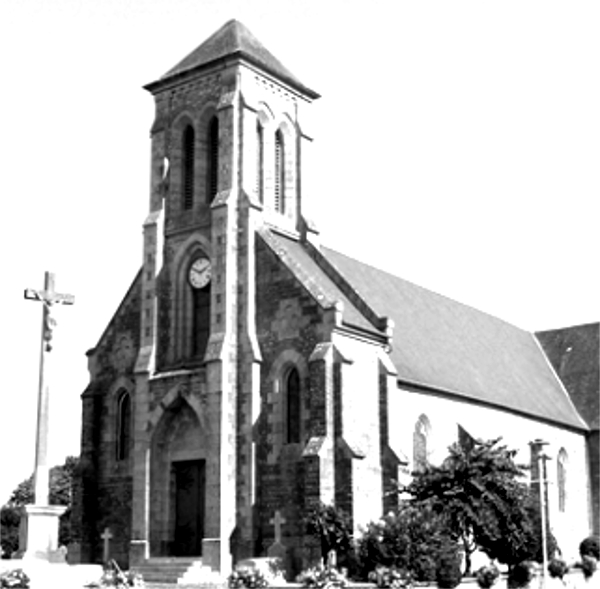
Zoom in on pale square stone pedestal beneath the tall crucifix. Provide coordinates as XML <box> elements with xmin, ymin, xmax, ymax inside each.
<box><xmin>19</xmin><ymin>505</ymin><xmax>67</xmax><ymax>563</ymax></box>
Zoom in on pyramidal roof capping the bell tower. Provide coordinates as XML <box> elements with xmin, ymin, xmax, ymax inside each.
<box><xmin>146</xmin><ymin>19</ymin><xmax>319</xmax><ymax>98</ymax></box>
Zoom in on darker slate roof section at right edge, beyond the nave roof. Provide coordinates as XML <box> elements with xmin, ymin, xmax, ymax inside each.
<box><xmin>536</xmin><ymin>323</ymin><xmax>600</xmax><ymax>430</ymax></box>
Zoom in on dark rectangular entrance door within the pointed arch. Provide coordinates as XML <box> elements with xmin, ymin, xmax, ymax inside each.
<box><xmin>172</xmin><ymin>460</ymin><xmax>206</xmax><ymax>556</ymax></box>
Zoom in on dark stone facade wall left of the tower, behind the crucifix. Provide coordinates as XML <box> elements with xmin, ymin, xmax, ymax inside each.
<box><xmin>72</xmin><ymin>276</ymin><xmax>140</xmax><ymax>566</ymax></box>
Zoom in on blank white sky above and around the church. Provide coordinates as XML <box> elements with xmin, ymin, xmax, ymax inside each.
<box><xmin>0</xmin><ymin>0</ymin><xmax>600</xmax><ymax>504</ymax></box>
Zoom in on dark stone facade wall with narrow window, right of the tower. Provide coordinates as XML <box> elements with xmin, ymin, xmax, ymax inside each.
<box><xmin>256</xmin><ymin>234</ymin><xmax>324</xmax><ymax>570</ymax></box>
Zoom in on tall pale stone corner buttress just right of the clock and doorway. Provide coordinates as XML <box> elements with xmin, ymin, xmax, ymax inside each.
<box><xmin>202</xmin><ymin>80</ymin><xmax>240</xmax><ymax>576</ymax></box>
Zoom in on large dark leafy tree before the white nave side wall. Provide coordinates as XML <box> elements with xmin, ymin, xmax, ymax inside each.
<box><xmin>404</xmin><ymin>438</ymin><xmax>539</xmax><ymax>573</ymax></box>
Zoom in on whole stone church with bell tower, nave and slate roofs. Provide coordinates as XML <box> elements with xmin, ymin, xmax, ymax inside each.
<box><xmin>72</xmin><ymin>20</ymin><xmax>600</xmax><ymax>580</ymax></box>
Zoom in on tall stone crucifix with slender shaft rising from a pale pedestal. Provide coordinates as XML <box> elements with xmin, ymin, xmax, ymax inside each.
<box><xmin>25</xmin><ymin>272</ymin><xmax>75</xmax><ymax>505</ymax></box>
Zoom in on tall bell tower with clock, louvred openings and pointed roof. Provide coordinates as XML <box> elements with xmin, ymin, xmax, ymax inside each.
<box><xmin>132</xmin><ymin>20</ymin><xmax>318</xmax><ymax>574</ymax></box>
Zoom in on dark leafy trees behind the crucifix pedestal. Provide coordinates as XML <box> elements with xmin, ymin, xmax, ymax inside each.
<box><xmin>0</xmin><ymin>456</ymin><xmax>79</xmax><ymax>557</ymax></box>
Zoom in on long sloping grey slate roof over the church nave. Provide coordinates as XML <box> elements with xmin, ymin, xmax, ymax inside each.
<box><xmin>321</xmin><ymin>241</ymin><xmax>587</xmax><ymax>430</ymax></box>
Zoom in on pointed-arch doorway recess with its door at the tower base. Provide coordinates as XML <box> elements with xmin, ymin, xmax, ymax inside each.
<box><xmin>150</xmin><ymin>397</ymin><xmax>206</xmax><ymax>556</ymax></box>
